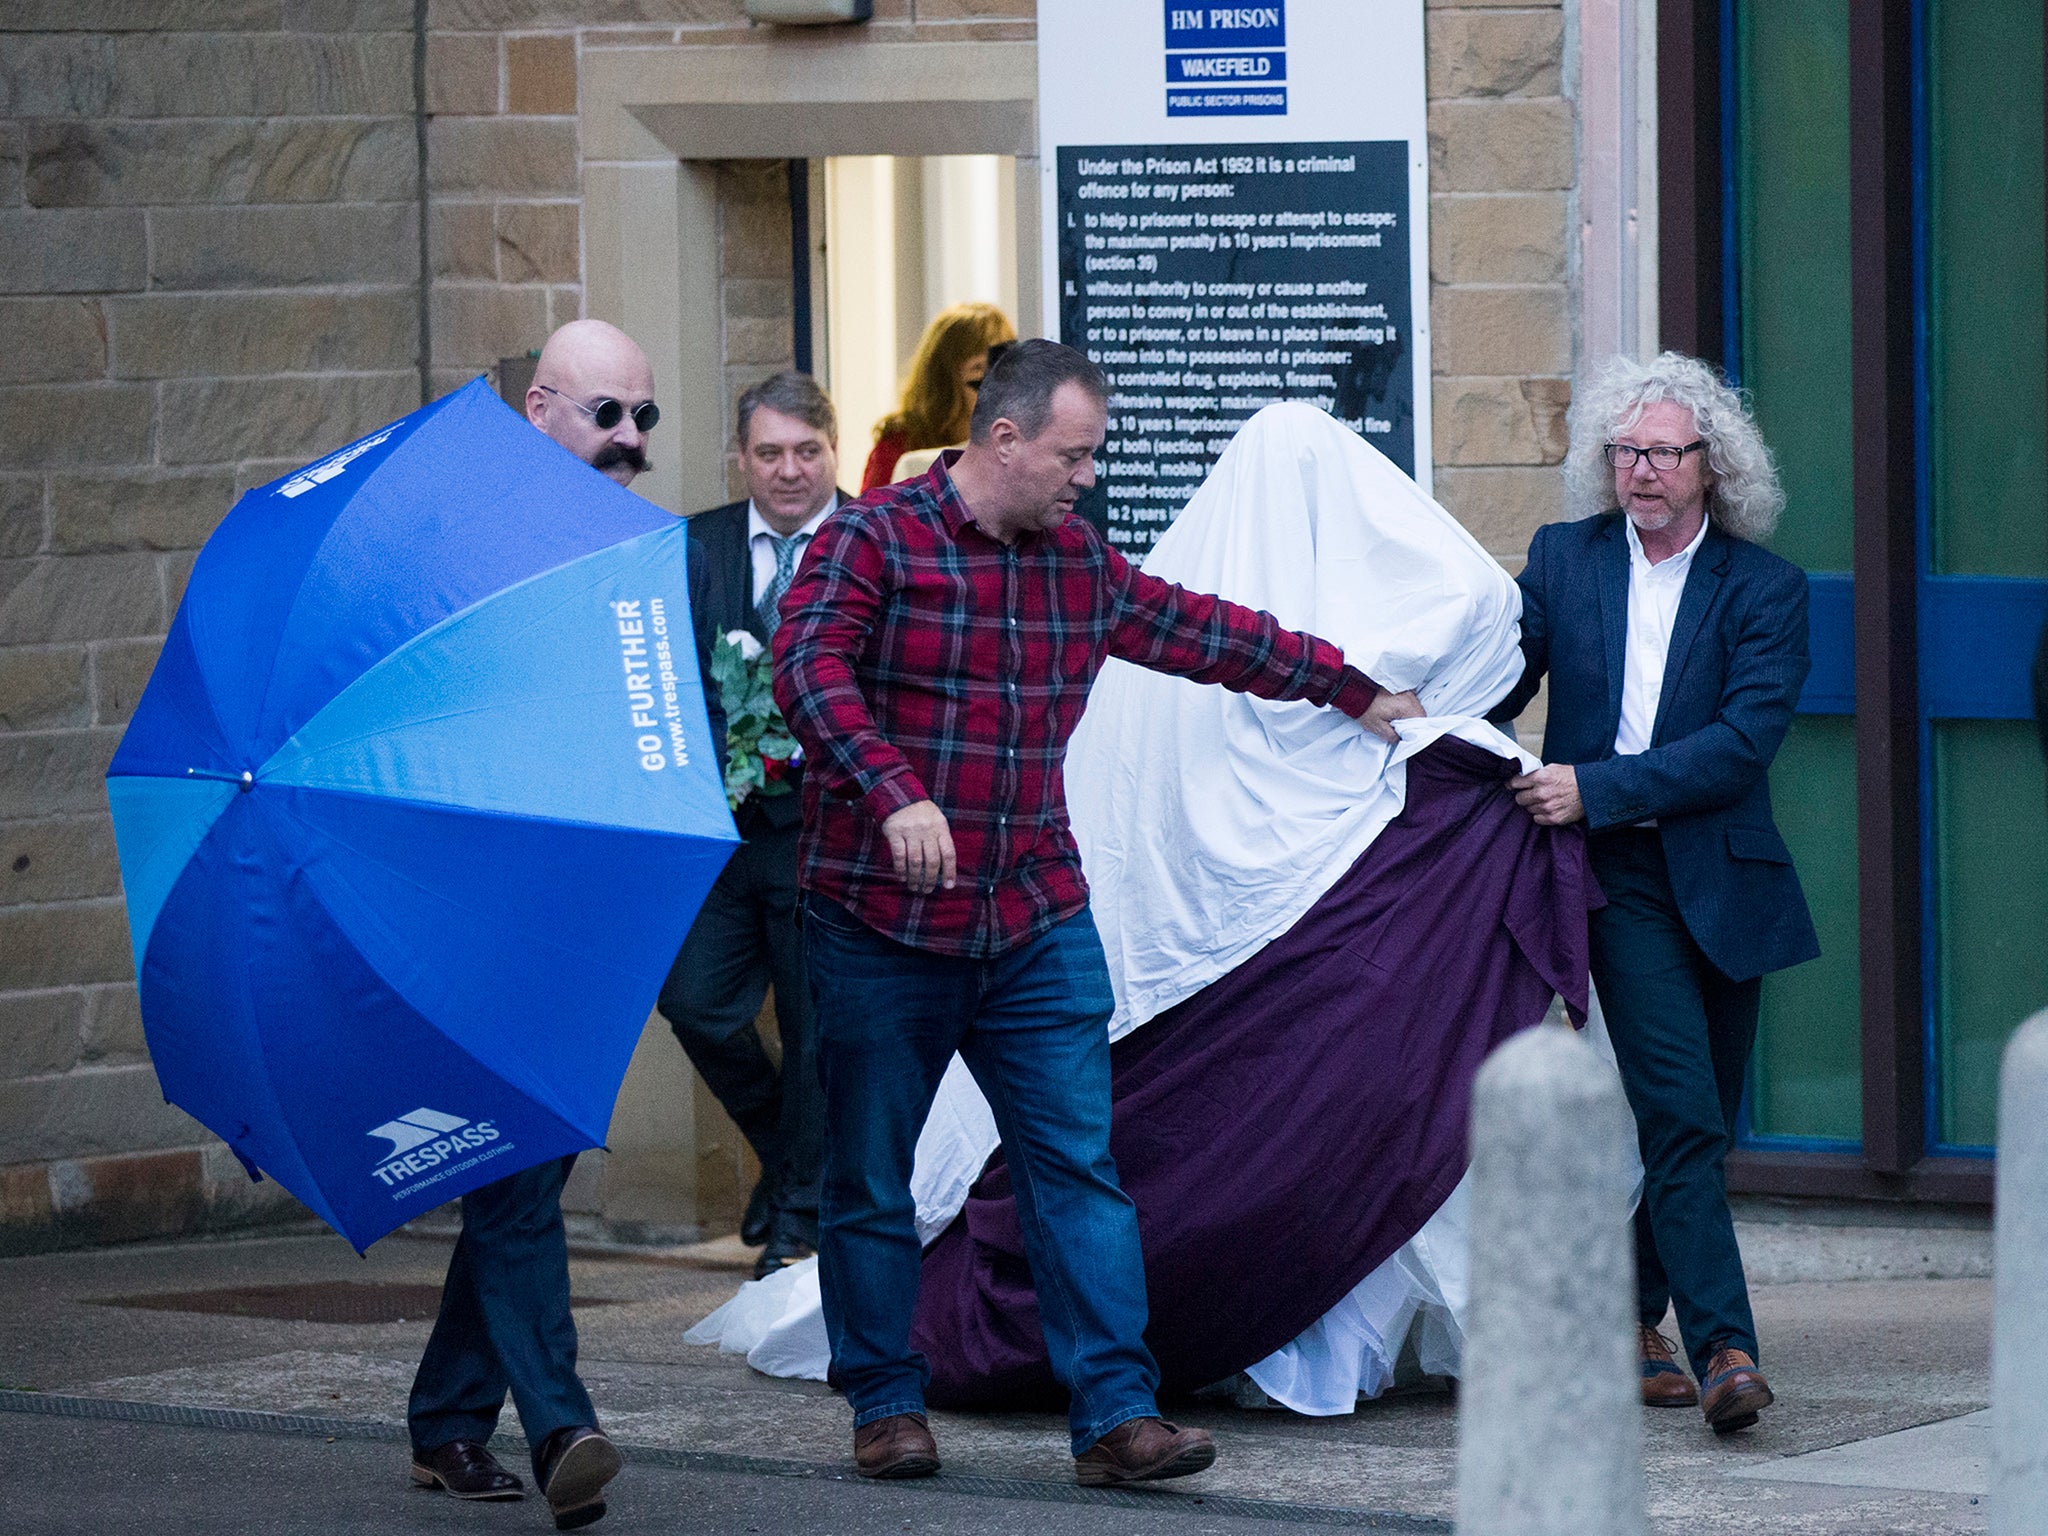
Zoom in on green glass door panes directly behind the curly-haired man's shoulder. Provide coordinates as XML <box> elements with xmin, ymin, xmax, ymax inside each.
<box><xmin>1729</xmin><ymin>0</ymin><xmax>1862</xmax><ymax>1143</ymax></box>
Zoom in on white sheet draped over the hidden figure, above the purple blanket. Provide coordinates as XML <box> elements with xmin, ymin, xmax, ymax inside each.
<box><xmin>686</xmin><ymin>406</ymin><xmax>1605</xmax><ymax>1413</ymax></box>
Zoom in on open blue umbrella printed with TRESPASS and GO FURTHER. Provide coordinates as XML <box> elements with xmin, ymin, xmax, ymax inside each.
<box><xmin>106</xmin><ymin>381</ymin><xmax>737</xmax><ymax>1249</ymax></box>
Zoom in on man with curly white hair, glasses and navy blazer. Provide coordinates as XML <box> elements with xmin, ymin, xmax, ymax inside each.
<box><xmin>1493</xmin><ymin>352</ymin><xmax>1821</xmax><ymax>1434</ymax></box>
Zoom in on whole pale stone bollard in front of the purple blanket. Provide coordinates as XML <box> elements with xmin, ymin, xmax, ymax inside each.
<box><xmin>1458</xmin><ymin>1024</ymin><xmax>1645</xmax><ymax>1536</ymax></box>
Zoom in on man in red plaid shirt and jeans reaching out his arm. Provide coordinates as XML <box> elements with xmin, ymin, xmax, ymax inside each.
<box><xmin>774</xmin><ymin>340</ymin><xmax>1421</xmax><ymax>1485</ymax></box>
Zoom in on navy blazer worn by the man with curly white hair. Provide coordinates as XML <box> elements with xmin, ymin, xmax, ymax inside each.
<box><xmin>1491</xmin><ymin>512</ymin><xmax>1821</xmax><ymax>981</ymax></box>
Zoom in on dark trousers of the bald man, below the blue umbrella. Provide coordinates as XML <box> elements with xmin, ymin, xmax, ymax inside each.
<box><xmin>406</xmin><ymin>1155</ymin><xmax>598</xmax><ymax>1479</ymax></box>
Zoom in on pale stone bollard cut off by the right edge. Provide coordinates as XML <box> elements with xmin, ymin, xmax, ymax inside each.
<box><xmin>1991</xmin><ymin>1010</ymin><xmax>2048</xmax><ymax>1536</ymax></box>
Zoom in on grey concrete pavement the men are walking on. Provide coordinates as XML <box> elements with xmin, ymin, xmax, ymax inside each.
<box><xmin>0</xmin><ymin>1223</ymin><xmax>1991</xmax><ymax>1536</ymax></box>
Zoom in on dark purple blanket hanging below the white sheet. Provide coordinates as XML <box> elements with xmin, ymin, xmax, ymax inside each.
<box><xmin>911</xmin><ymin>739</ymin><xmax>1602</xmax><ymax>1407</ymax></box>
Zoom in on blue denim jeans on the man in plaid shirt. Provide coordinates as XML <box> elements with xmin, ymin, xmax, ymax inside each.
<box><xmin>803</xmin><ymin>897</ymin><xmax>1159</xmax><ymax>1456</ymax></box>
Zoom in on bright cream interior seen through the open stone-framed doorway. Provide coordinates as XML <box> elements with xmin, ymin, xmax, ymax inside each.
<box><xmin>813</xmin><ymin>156</ymin><xmax>1015</xmax><ymax>487</ymax></box>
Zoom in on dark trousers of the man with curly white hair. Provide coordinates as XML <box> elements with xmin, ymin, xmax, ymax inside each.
<box><xmin>1589</xmin><ymin>827</ymin><xmax>1763</xmax><ymax>1376</ymax></box>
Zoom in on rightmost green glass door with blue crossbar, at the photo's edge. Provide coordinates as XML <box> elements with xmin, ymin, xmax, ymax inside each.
<box><xmin>1921</xmin><ymin>0</ymin><xmax>2048</xmax><ymax>1147</ymax></box>
